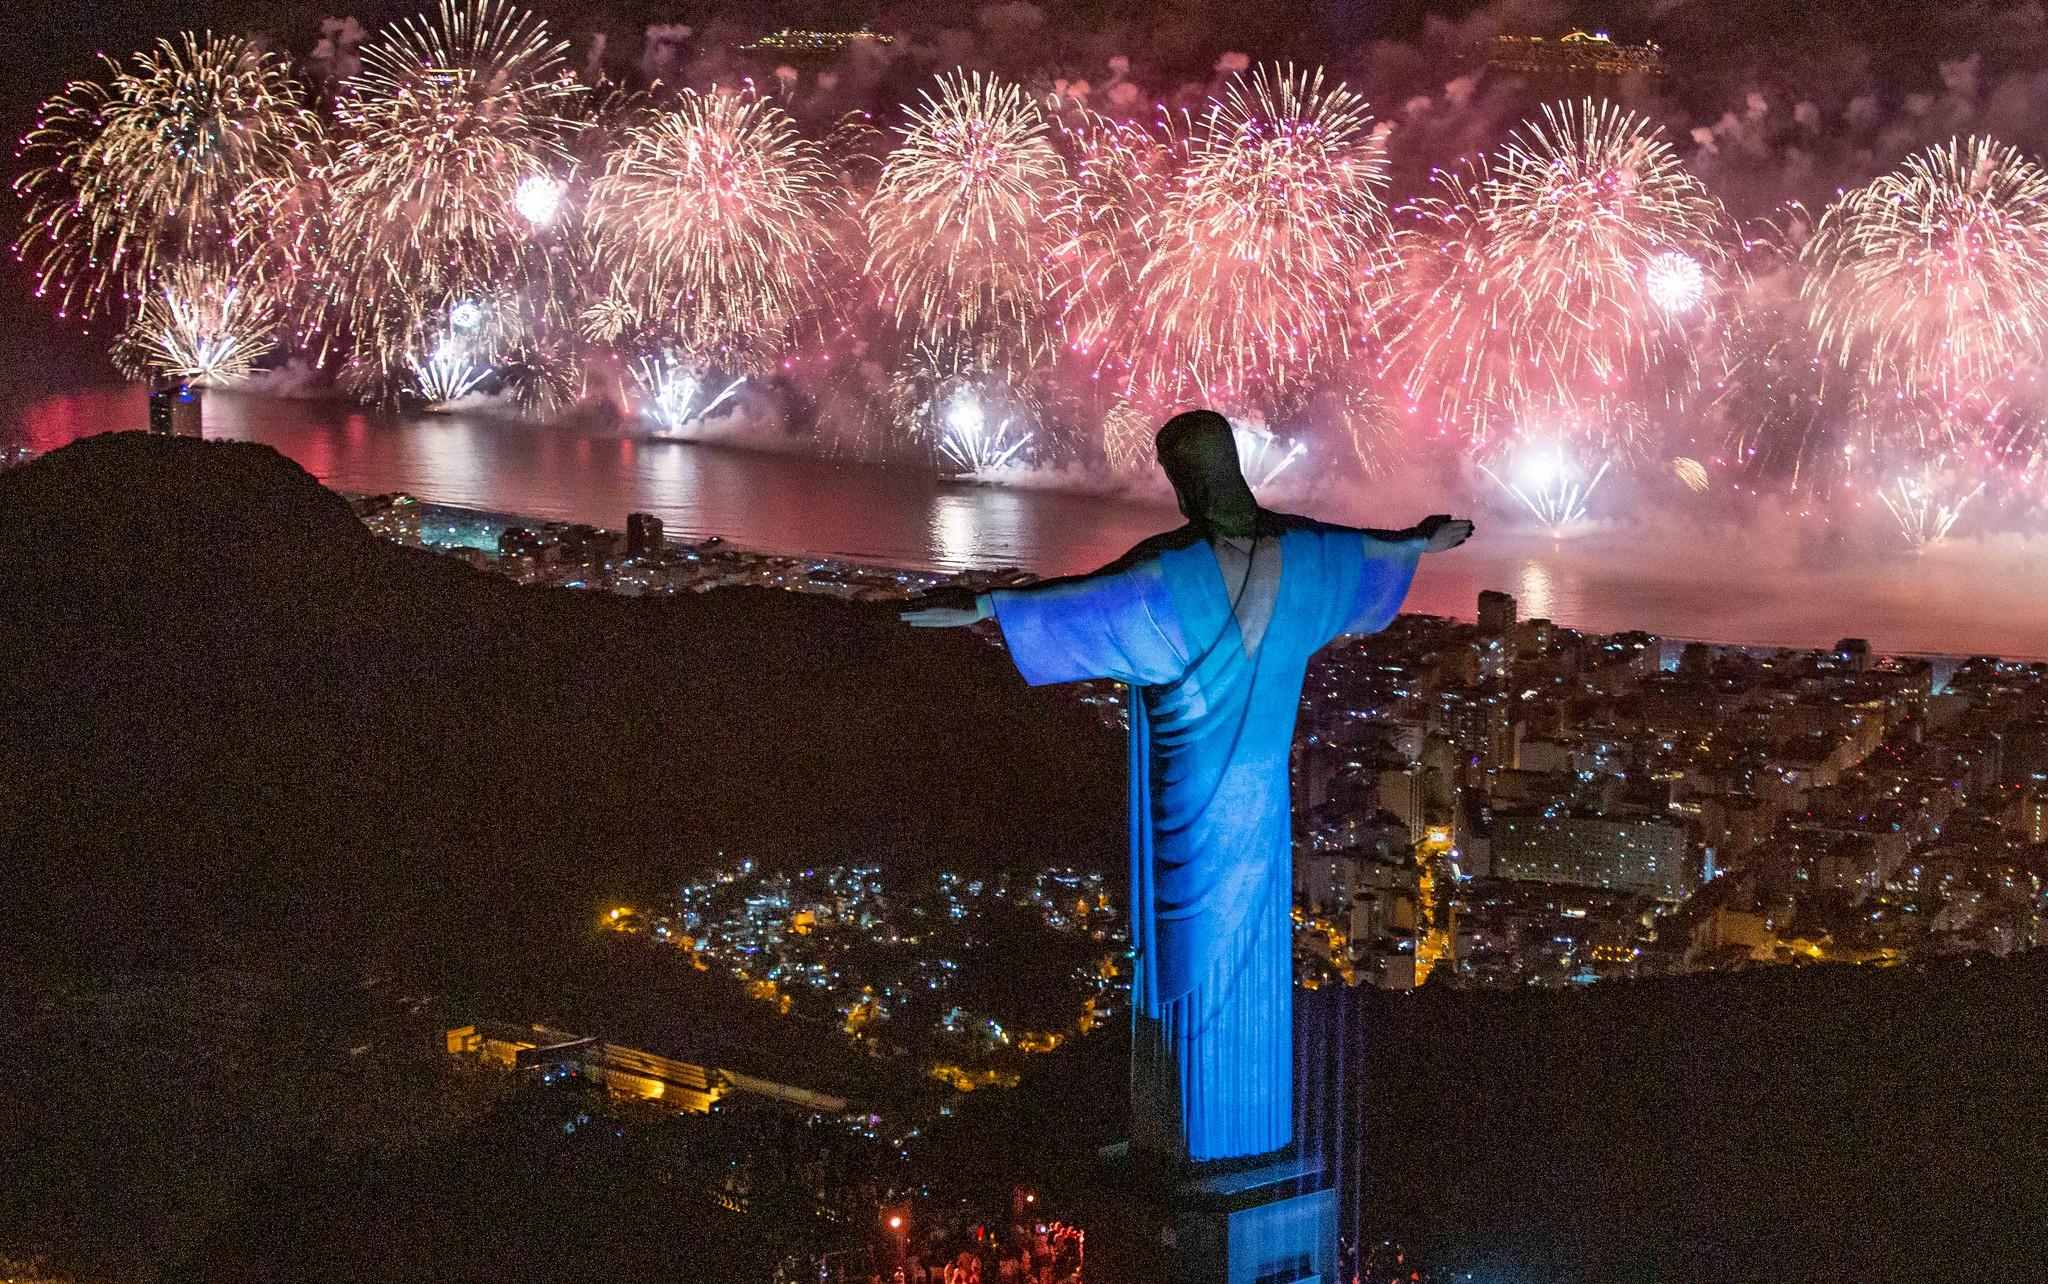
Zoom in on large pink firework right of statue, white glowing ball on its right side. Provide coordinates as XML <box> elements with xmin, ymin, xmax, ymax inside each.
<box><xmin>1384</xmin><ymin>100</ymin><xmax>1726</xmax><ymax>442</ymax></box>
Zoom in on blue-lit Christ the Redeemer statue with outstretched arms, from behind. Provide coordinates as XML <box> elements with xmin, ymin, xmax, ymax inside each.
<box><xmin>903</xmin><ymin>410</ymin><xmax>1473</xmax><ymax>1163</ymax></box>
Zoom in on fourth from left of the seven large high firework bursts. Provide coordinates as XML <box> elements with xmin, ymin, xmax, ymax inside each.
<box><xmin>862</xmin><ymin>74</ymin><xmax>1065</xmax><ymax>350</ymax></box>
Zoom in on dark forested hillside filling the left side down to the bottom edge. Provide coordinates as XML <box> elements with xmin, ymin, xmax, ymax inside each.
<box><xmin>0</xmin><ymin>434</ymin><xmax>1122</xmax><ymax>1280</ymax></box>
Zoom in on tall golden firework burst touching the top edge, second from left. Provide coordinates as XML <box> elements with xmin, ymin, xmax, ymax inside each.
<box><xmin>324</xmin><ymin>0</ymin><xmax>584</xmax><ymax>385</ymax></box>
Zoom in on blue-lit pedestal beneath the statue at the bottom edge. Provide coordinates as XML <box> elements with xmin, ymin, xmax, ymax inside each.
<box><xmin>1081</xmin><ymin>1145</ymin><xmax>1337</xmax><ymax>1284</ymax></box>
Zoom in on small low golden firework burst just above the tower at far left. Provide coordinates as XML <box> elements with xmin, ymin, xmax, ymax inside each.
<box><xmin>113</xmin><ymin>262</ymin><xmax>283</xmax><ymax>387</ymax></box>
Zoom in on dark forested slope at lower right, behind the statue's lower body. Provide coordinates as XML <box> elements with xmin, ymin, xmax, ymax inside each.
<box><xmin>938</xmin><ymin>950</ymin><xmax>2048</xmax><ymax>1284</ymax></box>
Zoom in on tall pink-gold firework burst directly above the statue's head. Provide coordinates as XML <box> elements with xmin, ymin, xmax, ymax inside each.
<box><xmin>1120</xmin><ymin>68</ymin><xmax>1386</xmax><ymax>403</ymax></box>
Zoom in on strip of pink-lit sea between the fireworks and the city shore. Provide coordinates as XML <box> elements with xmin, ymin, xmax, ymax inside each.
<box><xmin>14</xmin><ymin>389</ymin><xmax>2048</xmax><ymax>657</ymax></box>
